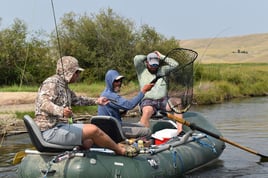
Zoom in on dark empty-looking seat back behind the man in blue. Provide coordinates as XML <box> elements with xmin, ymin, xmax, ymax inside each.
<box><xmin>90</xmin><ymin>116</ymin><xmax>126</xmax><ymax>143</ymax></box>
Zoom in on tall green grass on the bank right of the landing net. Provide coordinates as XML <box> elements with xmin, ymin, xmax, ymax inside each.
<box><xmin>194</xmin><ymin>63</ymin><xmax>268</xmax><ymax>104</ymax></box>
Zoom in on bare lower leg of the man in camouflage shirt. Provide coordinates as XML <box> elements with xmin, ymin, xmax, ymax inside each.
<box><xmin>82</xmin><ymin>124</ymin><xmax>126</xmax><ymax>155</ymax></box>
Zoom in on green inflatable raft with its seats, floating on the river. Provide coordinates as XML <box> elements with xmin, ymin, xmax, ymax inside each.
<box><xmin>18</xmin><ymin>112</ymin><xmax>225</xmax><ymax>178</ymax></box>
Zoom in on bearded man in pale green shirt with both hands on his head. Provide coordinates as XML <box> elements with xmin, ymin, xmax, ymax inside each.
<box><xmin>134</xmin><ymin>51</ymin><xmax>184</xmax><ymax>135</ymax></box>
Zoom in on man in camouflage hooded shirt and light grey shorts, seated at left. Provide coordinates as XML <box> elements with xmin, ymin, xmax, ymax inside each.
<box><xmin>35</xmin><ymin>56</ymin><xmax>133</xmax><ymax>155</ymax></box>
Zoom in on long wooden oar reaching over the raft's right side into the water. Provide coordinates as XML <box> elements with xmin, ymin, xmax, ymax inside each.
<box><xmin>161</xmin><ymin>112</ymin><xmax>268</xmax><ymax>162</ymax></box>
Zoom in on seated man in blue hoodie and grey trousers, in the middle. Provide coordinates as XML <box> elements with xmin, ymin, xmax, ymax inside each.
<box><xmin>98</xmin><ymin>70</ymin><xmax>154</xmax><ymax>138</ymax></box>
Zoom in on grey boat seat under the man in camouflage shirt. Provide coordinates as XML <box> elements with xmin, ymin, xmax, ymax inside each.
<box><xmin>23</xmin><ymin>115</ymin><xmax>75</xmax><ymax>152</ymax></box>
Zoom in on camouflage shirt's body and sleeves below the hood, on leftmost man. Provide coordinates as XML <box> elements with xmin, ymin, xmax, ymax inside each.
<box><xmin>35</xmin><ymin>74</ymin><xmax>96</xmax><ymax>131</ymax></box>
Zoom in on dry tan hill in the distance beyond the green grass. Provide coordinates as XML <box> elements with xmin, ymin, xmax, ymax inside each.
<box><xmin>180</xmin><ymin>33</ymin><xmax>268</xmax><ymax>63</ymax></box>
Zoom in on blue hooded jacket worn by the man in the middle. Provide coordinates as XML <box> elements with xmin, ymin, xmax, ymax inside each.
<box><xmin>98</xmin><ymin>70</ymin><xmax>144</xmax><ymax>123</ymax></box>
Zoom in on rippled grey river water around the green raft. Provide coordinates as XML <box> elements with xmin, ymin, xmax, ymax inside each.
<box><xmin>0</xmin><ymin>97</ymin><xmax>268</xmax><ymax>178</ymax></box>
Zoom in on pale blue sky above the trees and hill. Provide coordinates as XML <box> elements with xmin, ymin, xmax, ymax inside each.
<box><xmin>0</xmin><ymin>0</ymin><xmax>268</xmax><ymax>40</ymax></box>
